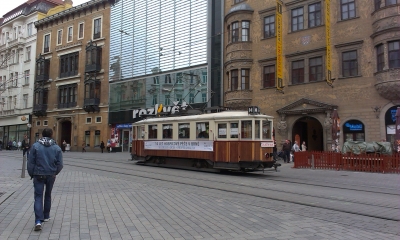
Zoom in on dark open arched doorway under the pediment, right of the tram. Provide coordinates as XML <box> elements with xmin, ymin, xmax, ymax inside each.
<box><xmin>292</xmin><ymin>116</ymin><xmax>324</xmax><ymax>151</ymax></box>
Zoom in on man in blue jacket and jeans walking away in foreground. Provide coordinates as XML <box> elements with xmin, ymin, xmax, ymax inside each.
<box><xmin>27</xmin><ymin>128</ymin><xmax>63</xmax><ymax>231</ymax></box>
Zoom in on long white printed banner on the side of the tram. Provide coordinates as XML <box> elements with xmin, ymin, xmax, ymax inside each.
<box><xmin>144</xmin><ymin>141</ymin><xmax>214</xmax><ymax>152</ymax></box>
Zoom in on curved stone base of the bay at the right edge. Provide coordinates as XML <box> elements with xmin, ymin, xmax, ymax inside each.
<box><xmin>375</xmin><ymin>68</ymin><xmax>400</xmax><ymax>101</ymax></box>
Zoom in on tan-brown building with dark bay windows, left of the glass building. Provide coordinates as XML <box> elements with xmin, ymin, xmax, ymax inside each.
<box><xmin>31</xmin><ymin>0</ymin><xmax>114</xmax><ymax>151</ymax></box>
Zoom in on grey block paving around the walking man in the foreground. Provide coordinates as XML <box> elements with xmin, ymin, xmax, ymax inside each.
<box><xmin>0</xmin><ymin>151</ymin><xmax>399</xmax><ymax>240</ymax></box>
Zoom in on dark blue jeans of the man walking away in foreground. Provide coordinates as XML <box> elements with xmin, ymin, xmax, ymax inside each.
<box><xmin>33</xmin><ymin>176</ymin><xmax>56</xmax><ymax>222</ymax></box>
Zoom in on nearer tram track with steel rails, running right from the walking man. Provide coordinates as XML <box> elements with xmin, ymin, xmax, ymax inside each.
<box><xmin>64</xmin><ymin>159</ymin><xmax>400</xmax><ymax>222</ymax></box>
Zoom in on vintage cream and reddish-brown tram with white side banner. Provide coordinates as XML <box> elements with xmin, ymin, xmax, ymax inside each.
<box><xmin>131</xmin><ymin>111</ymin><xmax>280</xmax><ymax>171</ymax></box>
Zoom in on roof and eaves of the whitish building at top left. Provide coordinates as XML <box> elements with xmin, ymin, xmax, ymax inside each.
<box><xmin>0</xmin><ymin>0</ymin><xmax>63</xmax><ymax>25</ymax></box>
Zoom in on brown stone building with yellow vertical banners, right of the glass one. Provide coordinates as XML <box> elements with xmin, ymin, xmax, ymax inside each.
<box><xmin>224</xmin><ymin>0</ymin><xmax>400</xmax><ymax>150</ymax></box>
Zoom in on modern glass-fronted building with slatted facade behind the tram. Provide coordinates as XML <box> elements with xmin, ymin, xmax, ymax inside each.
<box><xmin>109</xmin><ymin>0</ymin><xmax>224</xmax><ymax>152</ymax></box>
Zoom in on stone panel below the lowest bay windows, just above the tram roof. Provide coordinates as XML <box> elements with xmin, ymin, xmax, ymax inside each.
<box><xmin>225</xmin><ymin>90</ymin><xmax>253</xmax><ymax>110</ymax></box>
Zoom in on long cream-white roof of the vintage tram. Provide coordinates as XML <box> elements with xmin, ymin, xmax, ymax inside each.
<box><xmin>133</xmin><ymin>111</ymin><xmax>274</xmax><ymax>125</ymax></box>
